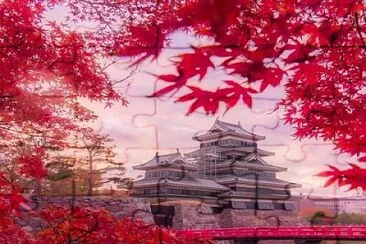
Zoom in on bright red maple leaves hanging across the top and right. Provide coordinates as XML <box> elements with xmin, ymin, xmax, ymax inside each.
<box><xmin>73</xmin><ymin>0</ymin><xmax>366</xmax><ymax>189</ymax></box>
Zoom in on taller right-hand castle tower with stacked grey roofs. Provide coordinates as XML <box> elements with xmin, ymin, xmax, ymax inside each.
<box><xmin>186</xmin><ymin>119</ymin><xmax>300</xmax><ymax>211</ymax></box>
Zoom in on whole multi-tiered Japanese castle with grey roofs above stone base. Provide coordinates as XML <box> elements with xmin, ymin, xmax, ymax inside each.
<box><xmin>133</xmin><ymin>119</ymin><xmax>300</xmax><ymax>211</ymax></box>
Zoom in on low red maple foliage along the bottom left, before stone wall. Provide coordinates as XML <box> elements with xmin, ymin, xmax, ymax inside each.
<box><xmin>37</xmin><ymin>207</ymin><xmax>211</xmax><ymax>244</ymax></box>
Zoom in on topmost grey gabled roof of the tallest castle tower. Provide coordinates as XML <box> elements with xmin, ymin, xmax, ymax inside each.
<box><xmin>193</xmin><ymin>118</ymin><xmax>265</xmax><ymax>141</ymax></box>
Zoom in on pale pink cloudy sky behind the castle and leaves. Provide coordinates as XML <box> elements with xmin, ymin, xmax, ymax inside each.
<box><xmin>45</xmin><ymin>4</ymin><xmax>355</xmax><ymax>197</ymax></box>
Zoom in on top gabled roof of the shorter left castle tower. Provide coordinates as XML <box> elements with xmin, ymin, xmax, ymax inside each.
<box><xmin>133</xmin><ymin>151</ymin><xmax>197</xmax><ymax>170</ymax></box>
